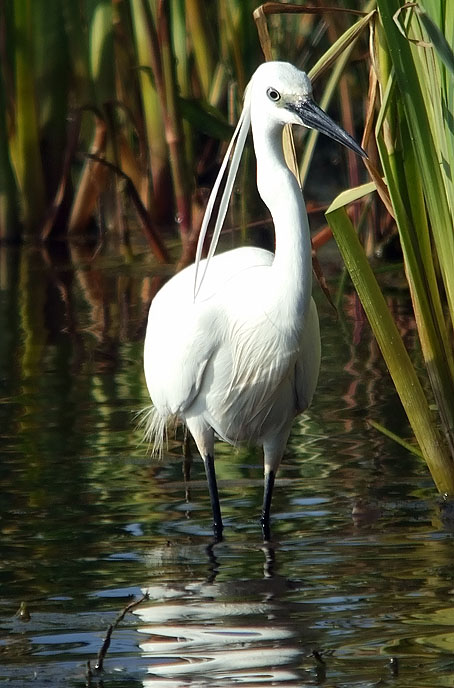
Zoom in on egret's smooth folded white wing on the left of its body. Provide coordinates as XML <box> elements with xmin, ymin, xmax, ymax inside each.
<box><xmin>144</xmin><ymin>247</ymin><xmax>272</xmax><ymax>415</ymax></box>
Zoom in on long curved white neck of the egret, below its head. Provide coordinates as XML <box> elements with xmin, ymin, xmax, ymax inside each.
<box><xmin>252</xmin><ymin>113</ymin><xmax>312</xmax><ymax>330</ymax></box>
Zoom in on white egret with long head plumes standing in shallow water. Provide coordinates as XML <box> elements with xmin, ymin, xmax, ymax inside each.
<box><xmin>144</xmin><ymin>62</ymin><xmax>366</xmax><ymax>540</ymax></box>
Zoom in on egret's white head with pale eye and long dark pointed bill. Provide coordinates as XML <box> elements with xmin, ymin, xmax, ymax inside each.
<box><xmin>247</xmin><ymin>62</ymin><xmax>367</xmax><ymax>157</ymax></box>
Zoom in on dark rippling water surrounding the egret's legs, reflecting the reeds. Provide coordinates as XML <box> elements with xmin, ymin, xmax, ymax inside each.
<box><xmin>0</xmin><ymin>239</ymin><xmax>454</xmax><ymax>688</ymax></box>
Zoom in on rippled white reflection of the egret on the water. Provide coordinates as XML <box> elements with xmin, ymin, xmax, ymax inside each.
<box><xmin>134</xmin><ymin>541</ymin><xmax>321</xmax><ymax>688</ymax></box>
